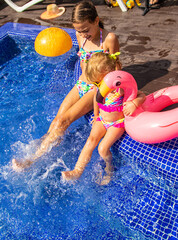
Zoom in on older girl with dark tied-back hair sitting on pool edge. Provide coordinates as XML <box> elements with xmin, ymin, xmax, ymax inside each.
<box><xmin>12</xmin><ymin>1</ymin><xmax>119</xmax><ymax>171</ymax></box>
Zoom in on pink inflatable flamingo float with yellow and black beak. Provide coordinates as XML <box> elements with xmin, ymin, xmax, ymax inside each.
<box><xmin>96</xmin><ymin>70</ymin><xmax>178</xmax><ymax>143</ymax></box>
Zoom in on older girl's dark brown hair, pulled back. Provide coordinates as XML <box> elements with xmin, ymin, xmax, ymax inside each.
<box><xmin>72</xmin><ymin>1</ymin><xmax>104</xmax><ymax>29</ymax></box>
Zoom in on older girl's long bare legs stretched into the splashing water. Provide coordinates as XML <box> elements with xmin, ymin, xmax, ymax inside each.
<box><xmin>12</xmin><ymin>86</ymin><xmax>94</xmax><ymax>171</ymax></box>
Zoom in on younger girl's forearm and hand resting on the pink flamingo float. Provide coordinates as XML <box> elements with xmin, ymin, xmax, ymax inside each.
<box><xmin>123</xmin><ymin>91</ymin><xmax>146</xmax><ymax>116</ymax></box>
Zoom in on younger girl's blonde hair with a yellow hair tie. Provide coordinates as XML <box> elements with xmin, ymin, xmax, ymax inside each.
<box><xmin>85</xmin><ymin>52</ymin><xmax>120</xmax><ymax>83</ymax></box>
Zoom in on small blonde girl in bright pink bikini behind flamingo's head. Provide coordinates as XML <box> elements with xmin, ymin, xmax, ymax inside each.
<box><xmin>62</xmin><ymin>52</ymin><xmax>145</xmax><ymax>185</ymax></box>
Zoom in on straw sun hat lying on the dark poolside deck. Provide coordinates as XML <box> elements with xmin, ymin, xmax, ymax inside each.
<box><xmin>40</xmin><ymin>4</ymin><xmax>65</xmax><ymax>19</ymax></box>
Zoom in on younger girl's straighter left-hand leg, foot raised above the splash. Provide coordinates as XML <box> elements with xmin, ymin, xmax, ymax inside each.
<box><xmin>62</xmin><ymin>122</ymin><xmax>106</xmax><ymax>181</ymax></box>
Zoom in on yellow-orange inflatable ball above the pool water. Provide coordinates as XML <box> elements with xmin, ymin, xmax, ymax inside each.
<box><xmin>35</xmin><ymin>27</ymin><xmax>72</xmax><ymax>57</ymax></box>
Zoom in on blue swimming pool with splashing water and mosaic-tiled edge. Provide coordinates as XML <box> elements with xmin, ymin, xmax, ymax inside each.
<box><xmin>0</xmin><ymin>23</ymin><xmax>178</xmax><ymax>240</ymax></box>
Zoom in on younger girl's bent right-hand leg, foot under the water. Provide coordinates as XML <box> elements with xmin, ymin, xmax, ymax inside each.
<box><xmin>98</xmin><ymin>127</ymin><xmax>124</xmax><ymax>185</ymax></box>
